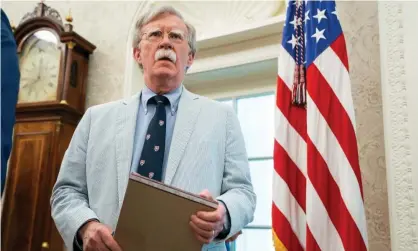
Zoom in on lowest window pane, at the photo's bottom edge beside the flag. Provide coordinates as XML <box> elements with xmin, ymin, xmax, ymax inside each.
<box><xmin>235</xmin><ymin>229</ymin><xmax>274</xmax><ymax>251</ymax></box>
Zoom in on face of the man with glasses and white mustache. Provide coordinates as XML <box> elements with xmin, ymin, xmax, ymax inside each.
<box><xmin>134</xmin><ymin>14</ymin><xmax>194</xmax><ymax>87</ymax></box>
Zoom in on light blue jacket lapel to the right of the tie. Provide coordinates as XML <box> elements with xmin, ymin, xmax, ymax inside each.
<box><xmin>164</xmin><ymin>88</ymin><xmax>200</xmax><ymax>184</ymax></box>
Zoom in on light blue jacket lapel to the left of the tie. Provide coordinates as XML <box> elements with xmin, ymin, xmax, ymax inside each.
<box><xmin>115</xmin><ymin>94</ymin><xmax>139</xmax><ymax>207</ymax></box>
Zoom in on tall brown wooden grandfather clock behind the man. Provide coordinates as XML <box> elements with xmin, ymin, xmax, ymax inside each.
<box><xmin>1</xmin><ymin>2</ymin><xmax>96</xmax><ymax>251</ymax></box>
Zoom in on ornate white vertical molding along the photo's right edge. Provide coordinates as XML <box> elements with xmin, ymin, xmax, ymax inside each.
<box><xmin>378</xmin><ymin>2</ymin><xmax>418</xmax><ymax>251</ymax></box>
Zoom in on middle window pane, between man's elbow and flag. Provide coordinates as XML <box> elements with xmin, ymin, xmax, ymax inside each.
<box><xmin>249</xmin><ymin>159</ymin><xmax>273</xmax><ymax>226</ymax></box>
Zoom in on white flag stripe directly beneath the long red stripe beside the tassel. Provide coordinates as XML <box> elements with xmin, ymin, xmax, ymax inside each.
<box><xmin>308</xmin><ymin>95</ymin><xmax>367</xmax><ymax>241</ymax></box>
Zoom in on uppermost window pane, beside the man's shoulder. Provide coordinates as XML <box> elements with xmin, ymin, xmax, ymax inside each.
<box><xmin>237</xmin><ymin>94</ymin><xmax>274</xmax><ymax>158</ymax></box>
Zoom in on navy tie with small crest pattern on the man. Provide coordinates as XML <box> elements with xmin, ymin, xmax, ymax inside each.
<box><xmin>138</xmin><ymin>95</ymin><xmax>170</xmax><ymax>181</ymax></box>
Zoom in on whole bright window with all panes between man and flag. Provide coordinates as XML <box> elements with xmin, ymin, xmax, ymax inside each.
<box><xmin>221</xmin><ymin>93</ymin><xmax>275</xmax><ymax>251</ymax></box>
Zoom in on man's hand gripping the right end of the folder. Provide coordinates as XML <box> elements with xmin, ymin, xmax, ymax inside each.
<box><xmin>190</xmin><ymin>190</ymin><xmax>226</xmax><ymax>244</ymax></box>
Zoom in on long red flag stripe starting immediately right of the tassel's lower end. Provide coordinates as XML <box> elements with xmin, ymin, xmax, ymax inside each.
<box><xmin>307</xmin><ymin>64</ymin><xmax>363</xmax><ymax>198</ymax></box>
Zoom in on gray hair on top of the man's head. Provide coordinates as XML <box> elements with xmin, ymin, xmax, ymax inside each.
<box><xmin>132</xmin><ymin>6</ymin><xmax>197</xmax><ymax>55</ymax></box>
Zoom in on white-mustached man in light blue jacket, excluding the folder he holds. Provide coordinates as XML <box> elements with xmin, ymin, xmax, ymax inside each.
<box><xmin>51</xmin><ymin>4</ymin><xmax>256</xmax><ymax>251</ymax></box>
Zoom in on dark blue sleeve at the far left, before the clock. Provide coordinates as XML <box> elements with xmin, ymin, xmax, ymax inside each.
<box><xmin>1</xmin><ymin>9</ymin><xmax>20</xmax><ymax>194</ymax></box>
